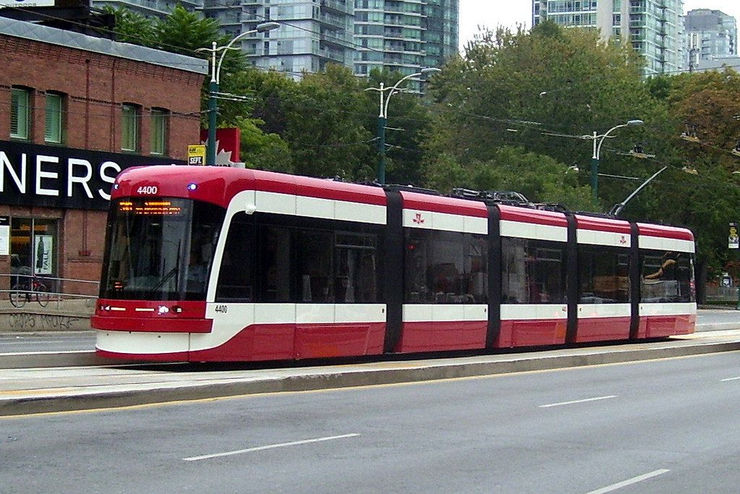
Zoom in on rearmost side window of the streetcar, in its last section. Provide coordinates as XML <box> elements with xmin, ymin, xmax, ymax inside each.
<box><xmin>640</xmin><ymin>250</ymin><xmax>696</xmax><ymax>303</ymax></box>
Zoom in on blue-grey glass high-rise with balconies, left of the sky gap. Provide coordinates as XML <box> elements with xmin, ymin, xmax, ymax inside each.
<box><xmin>198</xmin><ymin>0</ymin><xmax>459</xmax><ymax>82</ymax></box>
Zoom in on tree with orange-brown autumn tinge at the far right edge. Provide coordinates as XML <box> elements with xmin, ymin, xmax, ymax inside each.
<box><xmin>634</xmin><ymin>69</ymin><xmax>740</xmax><ymax>274</ymax></box>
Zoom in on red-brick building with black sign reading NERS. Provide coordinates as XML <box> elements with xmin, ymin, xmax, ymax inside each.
<box><xmin>0</xmin><ymin>18</ymin><xmax>208</xmax><ymax>294</ymax></box>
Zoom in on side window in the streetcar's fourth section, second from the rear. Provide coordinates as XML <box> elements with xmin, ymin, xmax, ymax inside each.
<box><xmin>578</xmin><ymin>245</ymin><xmax>630</xmax><ymax>304</ymax></box>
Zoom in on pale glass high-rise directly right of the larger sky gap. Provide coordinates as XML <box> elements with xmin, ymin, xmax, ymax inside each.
<box><xmin>532</xmin><ymin>0</ymin><xmax>683</xmax><ymax>75</ymax></box>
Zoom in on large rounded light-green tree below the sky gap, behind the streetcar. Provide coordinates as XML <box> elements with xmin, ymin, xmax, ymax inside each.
<box><xmin>427</xmin><ymin>22</ymin><xmax>659</xmax><ymax>210</ymax></box>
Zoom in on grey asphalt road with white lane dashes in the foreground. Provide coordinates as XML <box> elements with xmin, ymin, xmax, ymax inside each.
<box><xmin>0</xmin><ymin>352</ymin><xmax>740</xmax><ymax>494</ymax></box>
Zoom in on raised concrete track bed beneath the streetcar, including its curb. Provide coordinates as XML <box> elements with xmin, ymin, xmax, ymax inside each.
<box><xmin>0</xmin><ymin>329</ymin><xmax>740</xmax><ymax>416</ymax></box>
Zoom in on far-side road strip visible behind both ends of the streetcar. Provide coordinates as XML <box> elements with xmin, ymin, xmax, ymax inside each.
<box><xmin>0</xmin><ymin>310</ymin><xmax>740</xmax><ymax>353</ymax></box>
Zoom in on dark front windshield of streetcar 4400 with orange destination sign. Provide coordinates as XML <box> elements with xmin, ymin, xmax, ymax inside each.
<box><xmin>100</xmin><ymin>197</ymin><xmax>225</xmax><ymax>300</ymax></box>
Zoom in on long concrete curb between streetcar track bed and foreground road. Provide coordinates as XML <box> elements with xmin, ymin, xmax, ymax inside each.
<box><xmin>0</xmin><ymin>337</ymin><xmax>740</xmax><ymax>416</ymax></box>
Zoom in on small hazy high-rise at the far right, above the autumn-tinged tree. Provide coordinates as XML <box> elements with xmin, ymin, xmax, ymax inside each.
<box><xmin>685</xmin><ymin>9</ymin><xmax>738</xmax><ymax>70</ymax></box>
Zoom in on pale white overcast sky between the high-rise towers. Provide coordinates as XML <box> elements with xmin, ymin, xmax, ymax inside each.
<box><xmin>460</xmin><ymin>0</ymin><xmax>740</xmax><ymax>47</ymax></box>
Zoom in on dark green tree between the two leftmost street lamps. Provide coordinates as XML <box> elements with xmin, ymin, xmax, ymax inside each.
<box><xmin>224</xmin><ymin>65</ymin><xmax>374</xmax><ymax>181</ymax></box>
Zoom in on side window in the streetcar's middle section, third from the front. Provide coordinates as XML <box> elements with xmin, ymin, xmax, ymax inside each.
<box><xmin>501</xmin><ymin>237</ymin><xmax>566</xmax><ymax>304</ymax></box>
